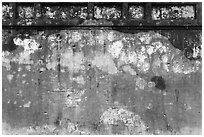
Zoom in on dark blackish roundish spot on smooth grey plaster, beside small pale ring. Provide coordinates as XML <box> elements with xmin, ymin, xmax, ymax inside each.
<box><xmin>151</xmin><ymin>76</ymin><xmax>166</xmax><ymax>90</ymax></box>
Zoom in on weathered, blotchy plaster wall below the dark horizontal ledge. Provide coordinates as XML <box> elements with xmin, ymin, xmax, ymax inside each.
<box><xmin>2</xmin><ymin>2</ymin><xmax>202</xmax><ymax>134</ymax></box>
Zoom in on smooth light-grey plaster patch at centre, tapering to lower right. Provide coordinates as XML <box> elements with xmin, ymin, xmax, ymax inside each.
<box><xmin>92</xmin><ymin>53</ymin><xmax>118</xmax><ymax>74</ymax></box>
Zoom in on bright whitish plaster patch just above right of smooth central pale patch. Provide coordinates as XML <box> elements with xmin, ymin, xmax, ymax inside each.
<box><xmin>108</xmin><ymin>40</ymin><xmax>123</xmax><ymax>58</ymax></box>
